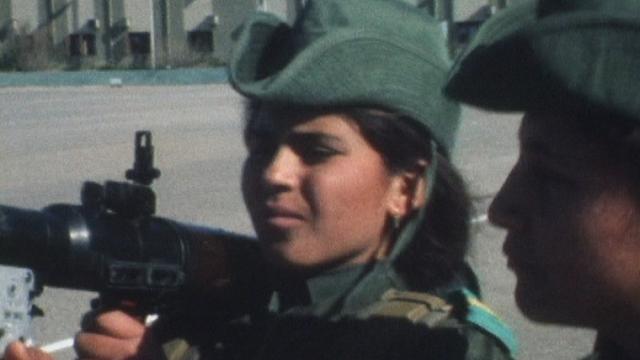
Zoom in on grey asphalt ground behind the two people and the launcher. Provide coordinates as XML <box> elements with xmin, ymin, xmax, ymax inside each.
<box><xmin>0</xmin><ymin>85</ymin><xmax>593</xmax><ymax>359</ymax></box>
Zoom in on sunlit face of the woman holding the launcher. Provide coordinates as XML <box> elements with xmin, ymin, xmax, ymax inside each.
<box><xmin>242</xmin><ymin>108</ymin><xmax>418</xmax><ymax>271</ymax></box>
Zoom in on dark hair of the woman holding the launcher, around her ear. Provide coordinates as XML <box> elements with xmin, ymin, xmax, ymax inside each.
<box><xmin>342</xmin><ymin>108</ymin><xmax>471</xmax><ymax>287</ymax></box>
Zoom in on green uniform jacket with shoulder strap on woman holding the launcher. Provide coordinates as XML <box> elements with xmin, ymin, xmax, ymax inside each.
<box><xmin>159</xmin><ymin>245</ymin><xmax>516</xmax><ymax>360</ymax></box>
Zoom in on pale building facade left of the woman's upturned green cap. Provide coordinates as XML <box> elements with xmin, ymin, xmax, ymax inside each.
<box><xmin>0</xmin><ymin>0</ymin><xmax>303</xmax><ymax>67</ymax></box>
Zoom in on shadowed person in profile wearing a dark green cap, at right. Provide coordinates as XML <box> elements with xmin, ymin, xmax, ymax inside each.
<box><xmin>447</xmin><ymin>0</ymin><xmax>640</xmax><ymax>359</ymax></box>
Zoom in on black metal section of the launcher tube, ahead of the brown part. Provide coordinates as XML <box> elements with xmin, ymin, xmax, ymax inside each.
<box><xmin>0</xmin><ymin>182</ymin><xmax>188</xmax><ymax>294</ymax></box>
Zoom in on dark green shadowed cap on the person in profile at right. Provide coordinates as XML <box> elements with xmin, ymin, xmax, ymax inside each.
<box><xmin>445</xmin><ymin>0</ymin><xmax>640</xmax><ymax>121</ymax></box>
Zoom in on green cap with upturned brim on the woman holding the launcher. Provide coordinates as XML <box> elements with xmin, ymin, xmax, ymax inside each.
<box><xmin>229</xmin><ymin>0</ymin><xmax>460</xmax><ymax>150</ymax></box>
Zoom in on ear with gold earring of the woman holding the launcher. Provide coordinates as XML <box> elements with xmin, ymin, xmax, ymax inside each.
<box><xmin>389</xmin><ymin>159</ymin><xmax>429</xmax><ymax>218</ymax></box>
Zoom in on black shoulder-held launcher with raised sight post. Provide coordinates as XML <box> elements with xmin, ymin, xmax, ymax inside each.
<box><xmin>0</xmin><ymin>131</ymin><xmax>270</xmax><ymax>314</ymax></box>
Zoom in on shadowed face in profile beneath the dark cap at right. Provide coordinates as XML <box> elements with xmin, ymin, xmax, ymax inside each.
<box><xmin>489</xmin><ymin>113</ymin><xmax>640</xmax><ymax>328</ymax></box>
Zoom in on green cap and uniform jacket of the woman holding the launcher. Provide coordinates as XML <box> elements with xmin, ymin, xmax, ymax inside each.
<box><xmin>157</xmin><ymin>0</ymin><xmax>515</xmax><ymax>360</ymax></box>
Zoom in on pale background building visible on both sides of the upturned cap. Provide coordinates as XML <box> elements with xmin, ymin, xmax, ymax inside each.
<box><xmin>0</xmin><ymin>0</ymin><xmax>515</xmax><ymax>70</ymax></box>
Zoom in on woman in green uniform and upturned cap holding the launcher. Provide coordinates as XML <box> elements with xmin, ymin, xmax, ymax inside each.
<box><xmin>9</xmin><ymin>0</ymin><xmax>513</xmax><ymax>359</ymax></box>
